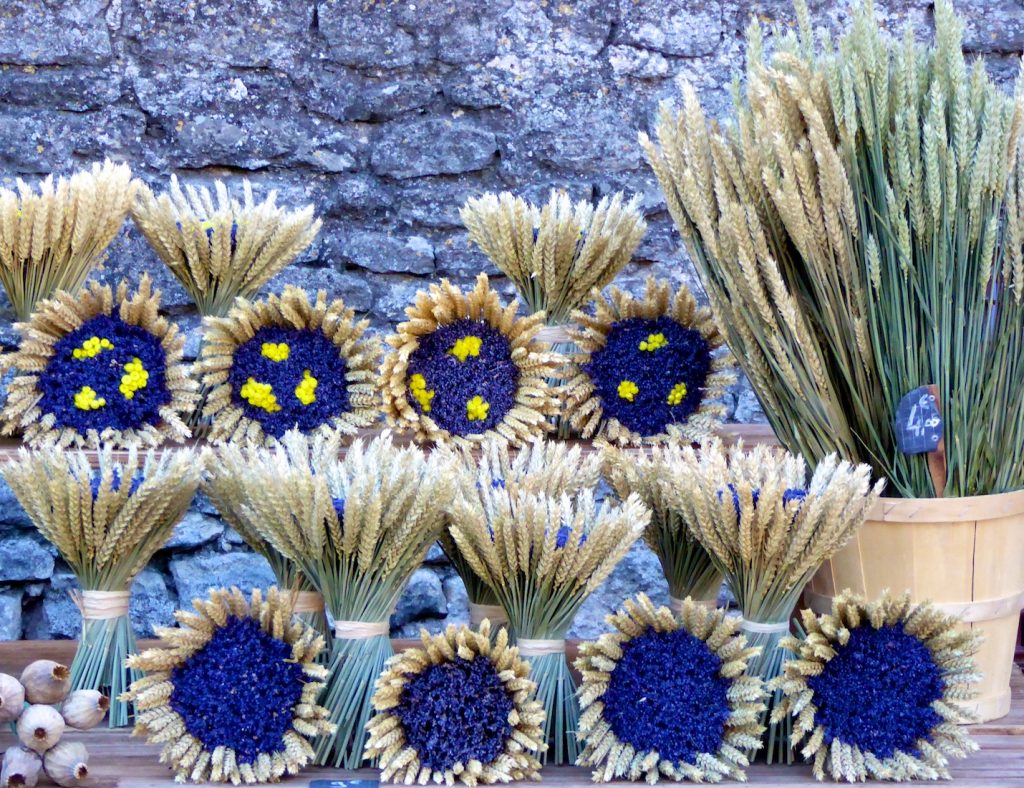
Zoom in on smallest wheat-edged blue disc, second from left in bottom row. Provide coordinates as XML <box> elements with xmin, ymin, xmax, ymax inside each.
<box><xmin>366</xmin><ymin>620</ymin><xmax>544</xmax><ymax>785</ymax></box>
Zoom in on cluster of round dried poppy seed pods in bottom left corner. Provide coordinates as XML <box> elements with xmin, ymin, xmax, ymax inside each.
<box><xmin>0</xmin><ymin>659</ymin><xmax>110</xmax><ymax>788</ymax></box>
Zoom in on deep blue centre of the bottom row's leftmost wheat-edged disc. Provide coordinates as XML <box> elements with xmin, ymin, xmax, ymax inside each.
<box><xmin>170</xmin><ymin>616</ymin><xmax>305</xmax><ymax>763</ymax></box>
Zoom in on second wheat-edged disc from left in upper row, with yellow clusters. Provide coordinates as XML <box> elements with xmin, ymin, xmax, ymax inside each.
<box><xmin>197</xmin><ymin>286</ymin><xmax>381</xmax><ymax>444</ymax></box>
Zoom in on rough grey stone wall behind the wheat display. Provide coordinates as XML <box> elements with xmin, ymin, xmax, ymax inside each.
<box><xmin>0</xmin><ymin>0</ymin><xmax>1024</xmax><ymax>639</ymax></box>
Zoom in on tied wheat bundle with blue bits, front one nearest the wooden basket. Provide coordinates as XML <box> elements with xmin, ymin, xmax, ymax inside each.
<box><xmin>663</xmin><ymin>440</ymin><xmax>885</xmax><ymax>763</ymax></box>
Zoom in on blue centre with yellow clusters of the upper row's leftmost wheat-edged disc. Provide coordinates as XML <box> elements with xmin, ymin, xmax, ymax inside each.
<box><xmin>38</xmin><ymin>315</ymin><xmax>171</xmax><ymax>433</ymax></box>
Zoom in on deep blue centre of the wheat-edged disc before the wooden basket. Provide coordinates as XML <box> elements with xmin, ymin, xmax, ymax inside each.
<box><xmin>807</xmin><ymin>624</ymin><xmax>944</xmax><ymax>758</ymax></box>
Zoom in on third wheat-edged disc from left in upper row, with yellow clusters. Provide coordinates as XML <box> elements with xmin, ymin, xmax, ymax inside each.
<box><xmin>381</xmin><ymin>273</ymin><xmax>563</xmax><ymax>444</ymax></box>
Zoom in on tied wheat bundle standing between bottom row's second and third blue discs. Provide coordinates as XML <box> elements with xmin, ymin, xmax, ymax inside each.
<box><xmin>450</xmin><ymin>466</ymin><xmax>649</xmax><ymax>763</ymax></box>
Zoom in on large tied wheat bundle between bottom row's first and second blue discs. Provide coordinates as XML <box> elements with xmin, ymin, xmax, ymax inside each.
<box><xmin>201</xmin><ymin>425</ymin><xmax>455</xmax><ymax>769</ymax></box>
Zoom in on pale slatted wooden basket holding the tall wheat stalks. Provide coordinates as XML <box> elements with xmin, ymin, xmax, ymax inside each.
<box><xmin>807</xmin><ymin>490</ymin><xmax>1024</xmax><ymax>721</ymax></box>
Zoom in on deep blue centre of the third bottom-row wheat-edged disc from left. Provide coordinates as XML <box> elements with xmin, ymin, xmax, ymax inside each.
<box><xmin>604</xmin><ymin>628</ymin><xmax>730</xmax><ymax>763</ymax></box>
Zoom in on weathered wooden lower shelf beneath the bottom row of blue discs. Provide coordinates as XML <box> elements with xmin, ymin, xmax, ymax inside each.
<box><xmin>0</xmin><ymin>641</ymin><xmax>1024</xmax><ymax>788</ymax></box>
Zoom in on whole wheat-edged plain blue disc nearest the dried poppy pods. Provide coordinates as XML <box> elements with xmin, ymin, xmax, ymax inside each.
<box><xmin>125</xmin><ymin>587</ymin><xmax>334</xmax><ymax>785</ymax></box>
